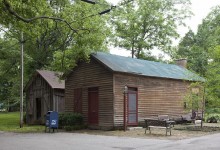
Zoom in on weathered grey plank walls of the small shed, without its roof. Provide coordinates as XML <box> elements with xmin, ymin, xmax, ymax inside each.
<box><xmin>26</xmin><ymin>74</ymin><xmax>64</xmax><ymax>124</ymax></box>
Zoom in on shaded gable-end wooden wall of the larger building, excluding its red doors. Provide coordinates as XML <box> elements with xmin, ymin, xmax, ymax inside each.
<box><xmin>65</xmin><ymin>59</ymin><xmax>113</xmax><ymax>129</ymax></box>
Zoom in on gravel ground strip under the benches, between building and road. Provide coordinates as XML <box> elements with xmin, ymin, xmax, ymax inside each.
<box><xmin>71</xmin><ymin>123</ymin><xmax>220</xmax><ymax>140</ymax></box>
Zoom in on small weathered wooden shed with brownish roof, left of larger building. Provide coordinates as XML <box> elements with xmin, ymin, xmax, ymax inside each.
<box><xmin>24</xmin><ymin>70</ymin><xmax>65</xmax><ymax>124</ymax></box>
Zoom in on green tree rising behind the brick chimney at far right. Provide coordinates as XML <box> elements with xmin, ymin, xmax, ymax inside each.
<box><xmin>176</xmin><ymin>6</ymin><xmax>220</xmax><ymax>76</ymax></box>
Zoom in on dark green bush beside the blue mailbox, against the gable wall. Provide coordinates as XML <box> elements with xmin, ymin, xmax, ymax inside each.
<box><xmin>59</xmin><ymin>113</ymin><xmax>84</xmax><ymax>131</ymax></box>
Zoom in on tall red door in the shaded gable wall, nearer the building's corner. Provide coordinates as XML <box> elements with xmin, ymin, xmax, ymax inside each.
<box><xmin>88</xmin><ymin>88</ymin><xmax>99</xmax><ymax>125</ymax></box>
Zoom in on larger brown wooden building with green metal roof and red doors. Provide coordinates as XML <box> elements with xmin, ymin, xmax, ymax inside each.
<box><xmin>65</xmin><ymin>52</ymin><xmax>203</xmax><ymax>130</ymax></box>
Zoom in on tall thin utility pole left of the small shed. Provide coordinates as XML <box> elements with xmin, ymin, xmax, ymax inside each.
<box><xmin>20</xmin><ymin>32</ymin><xmax>24</xmax><ymax>128</ymax></box>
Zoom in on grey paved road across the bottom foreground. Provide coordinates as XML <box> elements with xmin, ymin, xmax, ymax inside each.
<box><xmin>0</xmin><ymin>131</ymin><xmax>220</xmax><ymax>150</ymax></box>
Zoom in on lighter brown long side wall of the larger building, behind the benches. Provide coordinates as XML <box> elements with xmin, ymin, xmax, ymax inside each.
<box><xmin>114</xmin><ymin>73</ymin><xmax>189</xmax><ymax>126</ymax></box>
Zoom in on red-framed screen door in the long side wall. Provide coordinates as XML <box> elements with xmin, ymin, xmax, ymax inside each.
<box><xmin>127</xmin><ymin>90</ymin><xmax>138</xmax><ymax>125</ymax></box>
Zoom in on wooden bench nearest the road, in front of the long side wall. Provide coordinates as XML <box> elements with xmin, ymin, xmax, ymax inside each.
<box><xmin>144</xmin><ymin>119</ymin><xmax>171</xmax><ymax>136</ymax></box>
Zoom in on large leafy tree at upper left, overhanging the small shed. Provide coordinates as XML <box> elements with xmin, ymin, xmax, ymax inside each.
<box><xmin>0</xmin><ymin>0</ymin><xmax>110</xmax><ymax>109</ymax></box>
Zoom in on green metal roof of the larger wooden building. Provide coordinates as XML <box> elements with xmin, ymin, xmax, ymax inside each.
<box><xmin>92</xmin><ymin>52</ymin><xmax>205</xmax><ymax>82</ymax></box>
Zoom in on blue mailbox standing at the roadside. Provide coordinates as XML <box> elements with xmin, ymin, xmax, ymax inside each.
<box><xmin>45</xmin><ymin>111</ymin><xmax>58</xmax><ymax>132</ymax></box>
